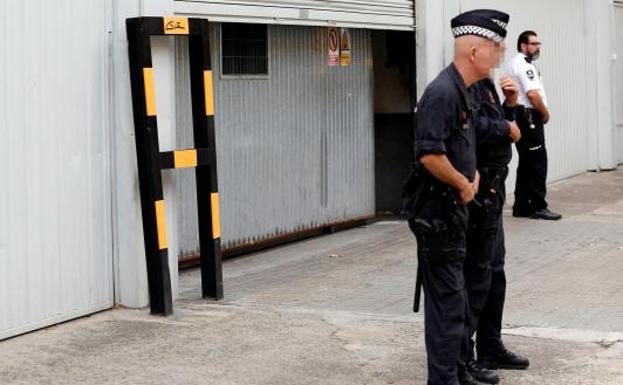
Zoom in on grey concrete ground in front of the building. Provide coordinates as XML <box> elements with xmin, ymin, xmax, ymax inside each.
<box><xmin>0</xmin><ymin>171</ymin><xmax>623</xmax><ymax>385</ymax></box>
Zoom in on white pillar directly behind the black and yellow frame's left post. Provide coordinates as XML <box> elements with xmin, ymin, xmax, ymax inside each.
<box><xmin>111</xmin><ymin>0</ymin><xmax>178</xmax><ymax>307</ymax></box>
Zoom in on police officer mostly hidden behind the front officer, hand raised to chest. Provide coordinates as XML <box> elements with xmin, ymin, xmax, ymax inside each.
<box><xmin>463</xmin><ymin>11</ymin><xmax>529</xmax><ymax>384</ymax></box>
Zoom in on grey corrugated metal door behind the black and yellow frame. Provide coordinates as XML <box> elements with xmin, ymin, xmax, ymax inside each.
<box><xmin>176</xmin><ymin>24</ymin><xmax>375</xmax><ymax>253</ymax></box>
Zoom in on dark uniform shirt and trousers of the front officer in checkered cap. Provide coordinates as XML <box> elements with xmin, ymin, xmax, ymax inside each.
<box><xmin>406</xmin><ymin>64</ymin><xmax>476</xmax><ymax>385</ymax></box>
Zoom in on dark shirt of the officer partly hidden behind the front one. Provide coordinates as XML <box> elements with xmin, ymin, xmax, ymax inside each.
<box><xmin>470</xmin><ymin>79</ymin><xmax>514</xmax><ymax>169</ymax></box>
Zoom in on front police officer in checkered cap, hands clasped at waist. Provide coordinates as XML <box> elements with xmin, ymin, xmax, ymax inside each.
<box><xmin>405</xmin><ymin>11</ymin><xmax>506</xmax><ymax>385</ymax></box>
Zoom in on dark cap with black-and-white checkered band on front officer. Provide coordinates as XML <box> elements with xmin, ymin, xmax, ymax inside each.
<box><xmin>450</xmin><ymin>9</ymin><xmax>510</xmax><ymax>43</ymax></box>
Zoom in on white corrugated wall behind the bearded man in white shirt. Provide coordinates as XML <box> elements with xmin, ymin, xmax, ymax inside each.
<box><xmin>460</xmin><ymin>0</ymin><xmax>595</xmax><ymax>187</ymax></box>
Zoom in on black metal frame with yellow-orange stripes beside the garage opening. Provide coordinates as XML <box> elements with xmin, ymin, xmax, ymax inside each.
<box><xmin>126</xmin><ymin>16</ymin><xmax>223</xmax><ymax>315</ymax></box>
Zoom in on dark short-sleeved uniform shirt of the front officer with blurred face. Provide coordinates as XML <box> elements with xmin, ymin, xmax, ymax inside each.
<box><xmin>415</xmin><ymin>64</ymin><xmax>476</xmax><ymax>181</ymax></box>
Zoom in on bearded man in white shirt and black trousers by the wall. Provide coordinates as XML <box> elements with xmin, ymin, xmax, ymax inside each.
<box><xmin>509</xmin><ymin>31</ymin><xmax>562</xmax><ymax>220</ymax></box>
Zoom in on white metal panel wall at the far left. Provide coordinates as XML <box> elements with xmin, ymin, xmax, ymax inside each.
<box><xmin>0</xmin><ymin>0</ymin><xmax>113</xmax><ymax>339</ymax></box>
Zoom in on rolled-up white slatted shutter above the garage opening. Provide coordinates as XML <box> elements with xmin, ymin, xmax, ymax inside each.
<box><xmin>175</xmin><ymin>0</ymin><xmax>415</xmax><ymax>30</ymax></box>
